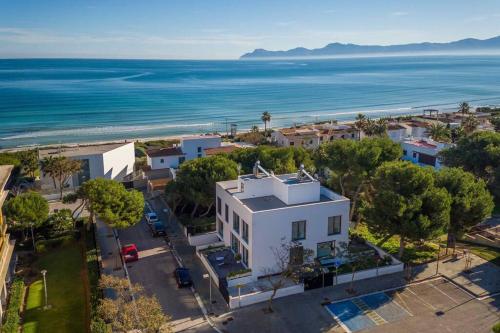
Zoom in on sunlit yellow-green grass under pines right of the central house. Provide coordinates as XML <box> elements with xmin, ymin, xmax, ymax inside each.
<box><xmin>351</xmin><ymin>224</ymin><xmax>437</xmax><ymax>264</ymax></box>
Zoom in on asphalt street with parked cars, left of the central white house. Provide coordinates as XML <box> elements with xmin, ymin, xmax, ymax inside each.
<box><xmin>119</xmin><ymin>201</ymin><xmax>213</xmax><ymax>332</ymax></box>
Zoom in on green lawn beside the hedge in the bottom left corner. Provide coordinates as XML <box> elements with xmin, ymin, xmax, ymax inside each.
<box><xmin>23</xmin><ymin>243</ymin><xmax>87</xmax><ymax>333</ymax></box>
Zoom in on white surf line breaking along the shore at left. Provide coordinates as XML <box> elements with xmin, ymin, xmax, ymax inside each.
<box><xmin>0</xmin><ymin>123</ymin><xmax>214</xmax><ymax>140</ymax></box>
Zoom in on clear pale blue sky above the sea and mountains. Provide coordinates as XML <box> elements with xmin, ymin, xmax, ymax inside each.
<box><xmin>0</xmin><ymin>0</ymin><xmax>500</xmax><ymax>59</ymax></box>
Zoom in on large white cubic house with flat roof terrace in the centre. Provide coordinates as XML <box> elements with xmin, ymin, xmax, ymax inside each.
<box><xmin>216</xmin><ymin>162</ymin><xmax>350</xmax><ymax>279</ymax></box>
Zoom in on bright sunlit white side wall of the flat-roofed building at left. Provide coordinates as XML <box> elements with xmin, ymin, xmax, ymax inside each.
<box><xmin>101</xmin><ymin>142</ymin><xmax>135</xmax><ymax>180</ymax></box>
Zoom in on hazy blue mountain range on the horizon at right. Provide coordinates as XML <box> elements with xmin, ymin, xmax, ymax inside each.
<box><xmin>240</xmin><ymin>36</ymin><xmax>500</xmax><ymax>59</ymax></box>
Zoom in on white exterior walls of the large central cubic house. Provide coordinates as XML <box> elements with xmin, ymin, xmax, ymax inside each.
<box><xmin>216</xmin><ymin>178</ymin><xmax>350</xmax><ymax>278</ymax></box>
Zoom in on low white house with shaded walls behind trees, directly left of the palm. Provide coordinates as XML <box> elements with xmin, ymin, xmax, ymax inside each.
<box><xmin>146</xmin><ymin>135</ymin><xmax>222</xmax><ymax>170</ymax></box>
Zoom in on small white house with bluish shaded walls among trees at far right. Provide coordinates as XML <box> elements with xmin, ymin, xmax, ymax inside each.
<box><xmin>401</xmin><ymin>138</ymin><xmax>451</xmax><ymax>169</ymax></box>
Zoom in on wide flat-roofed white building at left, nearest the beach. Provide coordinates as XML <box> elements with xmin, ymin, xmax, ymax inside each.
<box><xmin>39</xmin><ymin>142</ymin><xmax>135</xmax><ymax>189</ymax></box>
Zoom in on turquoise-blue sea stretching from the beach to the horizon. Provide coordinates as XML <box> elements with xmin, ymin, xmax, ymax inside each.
<box><xmin>0</xmin><ymin>56</ymin><xmax>500</xmax><ymax>148</ymax></box>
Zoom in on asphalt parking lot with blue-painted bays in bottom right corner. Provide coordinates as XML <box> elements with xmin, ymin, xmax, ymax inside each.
<box><xmin>324</xmin><ymin>278</ymin><xmax>498</xmax><ymax>332</ymax></box>
